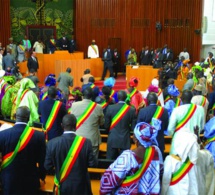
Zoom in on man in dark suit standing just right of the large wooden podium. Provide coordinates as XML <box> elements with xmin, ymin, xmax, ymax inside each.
<box><xmin>101</xmin><ymin>46</ymin><xmax>113</xmax><ymax>80</ymax></box>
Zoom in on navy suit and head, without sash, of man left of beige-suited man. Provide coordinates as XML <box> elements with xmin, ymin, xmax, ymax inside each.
<box><xmin>38</xmin><ymin>86</ymin><xmax>67</xmax><ymax>140</ymax></box>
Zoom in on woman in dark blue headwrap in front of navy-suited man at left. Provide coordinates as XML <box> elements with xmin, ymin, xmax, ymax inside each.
<box><xmin>39</xmin><ymin>74</ymin><xmax>63</xmax><ymax>101</ymax></box>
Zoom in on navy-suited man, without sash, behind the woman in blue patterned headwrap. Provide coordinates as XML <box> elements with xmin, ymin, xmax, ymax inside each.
<box><xmin>137</xmin><ymin>92</ymin><xmax>169</xmax><ymax>156</ymax></box>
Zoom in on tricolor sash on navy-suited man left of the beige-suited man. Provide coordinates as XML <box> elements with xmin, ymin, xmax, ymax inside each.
<box><xmin>45</xmin><ymin>101</ymin><xmax>62</xmax><ymax>133</ymax></box>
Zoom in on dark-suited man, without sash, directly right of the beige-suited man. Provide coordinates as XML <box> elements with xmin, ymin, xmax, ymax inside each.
<box><xmin>105</xmin><ymin>91</ymin><xmax>136</xmax><ymax>160</ymax></box>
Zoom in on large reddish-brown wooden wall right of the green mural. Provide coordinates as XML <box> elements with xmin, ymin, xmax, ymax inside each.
<box><xmin>75</xmin><ymin>0</ymin><xmax>203</xmax><ymax>69</ymax></box>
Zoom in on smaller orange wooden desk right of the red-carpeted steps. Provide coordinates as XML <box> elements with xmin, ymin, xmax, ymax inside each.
<box><xmin>126</xmin><ymin>65</ymin><xmax>158</xmax><ymax>91</ymax></box>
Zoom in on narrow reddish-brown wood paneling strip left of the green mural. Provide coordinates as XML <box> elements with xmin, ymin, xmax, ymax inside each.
<box><xmin>0</xmin><ymin>0</ymin><xmax>11</xmax><ymax>47</ymax></box>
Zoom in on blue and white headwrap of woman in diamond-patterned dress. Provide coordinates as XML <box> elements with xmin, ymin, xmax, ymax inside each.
<box><xmin>134</xmin><ymin>119</ymin><xmax>158</xmax><ymax>148</ymax></box>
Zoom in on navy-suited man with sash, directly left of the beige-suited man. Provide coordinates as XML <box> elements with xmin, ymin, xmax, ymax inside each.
<box><xmin>38</xmin><ymin>86</ymin><xmax>67</xmax><ymax>141</ymax></box>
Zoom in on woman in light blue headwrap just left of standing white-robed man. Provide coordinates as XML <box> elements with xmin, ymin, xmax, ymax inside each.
<box><xmin>164</xmin><ymin>85</ymin><xmax>182</xmax><ymax>117</ymax></box>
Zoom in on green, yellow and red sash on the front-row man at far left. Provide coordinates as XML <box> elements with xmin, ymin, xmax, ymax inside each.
<box><xmin>1</xmin><ymin>126</ymin><xmax>34</xmax><ymax>169</ymax></box>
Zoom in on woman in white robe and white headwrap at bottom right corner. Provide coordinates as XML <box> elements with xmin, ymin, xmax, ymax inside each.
<box><xmin>162</xmin><ymin>129</ymin><xmax>214</xmax><ymax>195</ymax></box>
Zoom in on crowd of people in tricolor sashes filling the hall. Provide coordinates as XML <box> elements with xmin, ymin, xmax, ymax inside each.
<box><xmin>0</xmin><ymin>36</ymin><xmax>215</xmax><ymax>195</ymax></box>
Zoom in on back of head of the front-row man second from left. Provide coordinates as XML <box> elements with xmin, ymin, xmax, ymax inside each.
<box><xmin>62</xmin><ymin>114</ymin><xmax>77</xmax><ymax>131</ymax></box>
